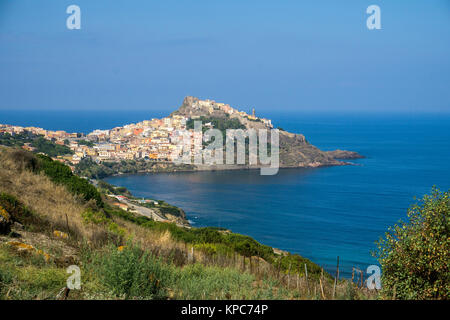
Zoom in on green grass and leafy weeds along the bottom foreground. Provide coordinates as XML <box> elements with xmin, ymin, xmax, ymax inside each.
<box><xmin>79</xmin><ymin>244</ymin><xmax>296</xmax><ymax>300</ymax></box>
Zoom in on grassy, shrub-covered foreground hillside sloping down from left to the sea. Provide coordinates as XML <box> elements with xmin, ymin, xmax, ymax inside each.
<box><xmin>0</xmin><ymin>147</ymin><xmax>367</xmax><ymax>299</ymax></box>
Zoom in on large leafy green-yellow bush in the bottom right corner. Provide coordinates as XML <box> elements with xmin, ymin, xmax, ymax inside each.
<box><xmin>375</xmin><ymin>188</ymin><xmax>450</xmax><ymax>299</ymax></box>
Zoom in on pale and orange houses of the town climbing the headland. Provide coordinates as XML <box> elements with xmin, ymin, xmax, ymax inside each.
<box><xmin>0</xmin><ymin>100</ymin><xmax>272</xmax><ymax>164</ymax></box>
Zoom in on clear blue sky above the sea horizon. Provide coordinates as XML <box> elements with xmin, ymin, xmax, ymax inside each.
<box><xmin>0</xmin><ymin>0</ymin><xmax>450</xmax><ymax>113</ymax></box>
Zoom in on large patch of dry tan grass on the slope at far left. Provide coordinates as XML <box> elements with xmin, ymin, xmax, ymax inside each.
<box><xmin>0</xmin><ymin>147</ymin><xmax>118</xmax><ymax>243</ymax></box>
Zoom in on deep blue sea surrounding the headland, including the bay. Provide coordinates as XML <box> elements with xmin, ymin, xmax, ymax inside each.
<box><xmin>0</xmin><ymin>111</ymin><xmax>450</xmax><ymax>276</ymax></box>
